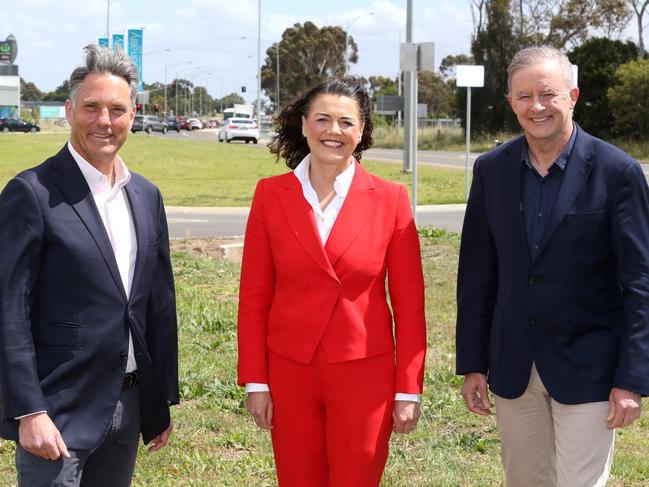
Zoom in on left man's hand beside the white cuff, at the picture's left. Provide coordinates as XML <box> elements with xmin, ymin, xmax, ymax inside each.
<box><xmin>18</xmin><ymin>413</ymin><xmax>70</xmax><ymax>460</ymax></box>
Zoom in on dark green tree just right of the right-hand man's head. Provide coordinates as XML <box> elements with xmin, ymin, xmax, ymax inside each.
<box><xmin>568</xmin><ymin>37</ymin><xmax>637</xmax><ymax>138</ymax></box>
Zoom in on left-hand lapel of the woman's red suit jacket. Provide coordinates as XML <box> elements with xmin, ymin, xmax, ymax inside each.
<box><xmin>277</xmin><ymin>174</ymin><xmax>338</xmax><ymax>279</ymax></box>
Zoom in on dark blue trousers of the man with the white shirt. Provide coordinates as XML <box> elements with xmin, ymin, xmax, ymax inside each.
<box><xmin>16</xmin><ymin>386</ymin><xmax>140</xmax><ymax>487</ymax></box>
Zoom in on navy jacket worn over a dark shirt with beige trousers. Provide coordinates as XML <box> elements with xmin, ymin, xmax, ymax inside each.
<box><xmin>457</xmin><ymin>127</ymin><xmax>649</xmax><ymax>404</ymax></box>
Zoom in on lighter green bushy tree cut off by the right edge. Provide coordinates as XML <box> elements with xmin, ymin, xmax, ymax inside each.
<box><xmin>608</xmin><ymin>59</ymin><xmax>649</xmax><ymax>139</ymax></box>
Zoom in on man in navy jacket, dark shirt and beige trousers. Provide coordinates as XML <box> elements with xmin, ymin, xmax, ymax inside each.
<box><xmin>457</xmin><ymin>47</ymin><xmax>649</xmax><ymax>487</ymax></box>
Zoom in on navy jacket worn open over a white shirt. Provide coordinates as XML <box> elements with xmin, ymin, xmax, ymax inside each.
<box><xmin>0</xmin><ymin>147</ymin><xmax>178</xmax><ymax>449</ymax></box>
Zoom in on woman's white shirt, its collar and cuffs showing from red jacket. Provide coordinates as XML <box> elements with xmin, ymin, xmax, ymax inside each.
<box><xmin>245</xmin><ymin>154</ymin><xmax>420</xmax><ymax>402</ymax></box>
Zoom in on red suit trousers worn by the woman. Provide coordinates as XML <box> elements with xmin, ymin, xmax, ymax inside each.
<box><xmin>268</xmin><ymin>347</ymin><xmax>395</xmax><ymax>487</ymax></box>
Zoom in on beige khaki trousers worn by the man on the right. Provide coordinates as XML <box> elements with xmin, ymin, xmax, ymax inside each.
<box><xmin>495</xmin><ymin>366</ymin><xmax>615</xmax><ymax>487</ymax></box>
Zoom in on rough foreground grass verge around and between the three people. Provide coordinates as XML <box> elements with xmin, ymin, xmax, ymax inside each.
<box><xmin>0</xmin><ymin>232</ymin><xmax>649</xmax><ymax>487</ymax></box>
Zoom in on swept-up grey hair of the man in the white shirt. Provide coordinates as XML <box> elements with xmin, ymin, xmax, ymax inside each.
<box><xmin>69</xmin><ymin>44</ymin><xmax>138</xmax><ymax>105</ymax></box>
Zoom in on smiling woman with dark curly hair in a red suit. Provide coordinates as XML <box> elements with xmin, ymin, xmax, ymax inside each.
<box><xmin>238</xmin><ymin>77</ymin><xmax>426</xmax><ymax>487</ymax></box>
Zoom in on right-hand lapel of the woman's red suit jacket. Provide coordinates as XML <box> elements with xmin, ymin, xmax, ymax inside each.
<box><xmin>325</xmin><ymin>162</ymin><xmax>385</xmax><ymax>266</ymax></box>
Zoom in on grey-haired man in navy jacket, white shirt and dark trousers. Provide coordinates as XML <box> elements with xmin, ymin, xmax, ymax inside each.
<box><xmin>0</xmin><ymin>46</ymin><xmax>178</xmax><ymax>486</ymax></box>
